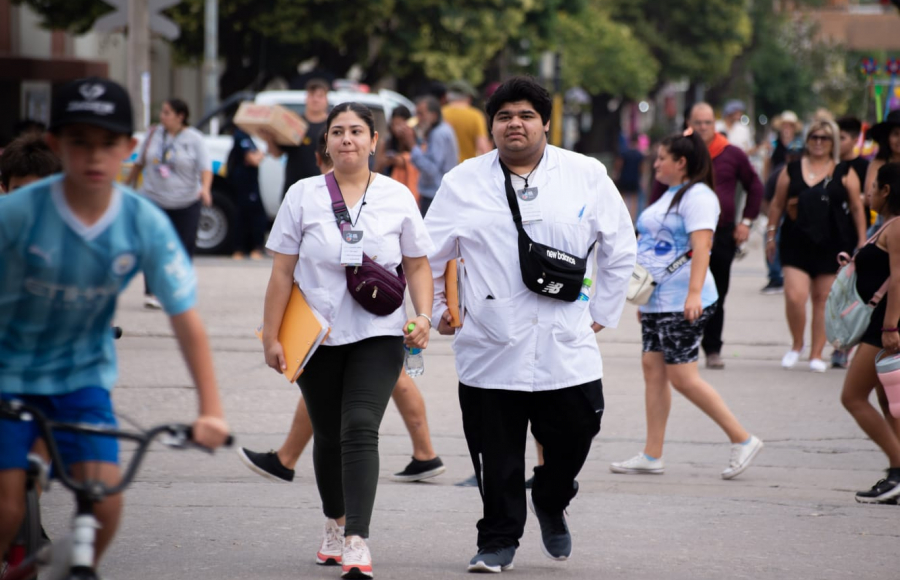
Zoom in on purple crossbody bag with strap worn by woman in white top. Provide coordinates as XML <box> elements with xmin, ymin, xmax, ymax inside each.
<box><xmin>325</xmin><ymin>173</ymin><xmax>406</xmax><ymax>316</ymax></box>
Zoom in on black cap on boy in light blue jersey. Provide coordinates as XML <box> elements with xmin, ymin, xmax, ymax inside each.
<box><xmin>49</xmin><ymin>77</ymin><xmax>134</xmax><ymax>135</ymax></box>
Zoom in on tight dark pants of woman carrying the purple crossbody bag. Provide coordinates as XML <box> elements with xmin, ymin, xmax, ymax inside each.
<box><xmin>297</xmin><ymin>336</ymin><xmax>403</xmax><ymax>538</ymax></box>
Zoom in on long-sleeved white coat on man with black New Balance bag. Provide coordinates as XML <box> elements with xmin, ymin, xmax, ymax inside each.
<box><xmin>425</xmin><ymin>145</ymin><xmax>636</xmax><ymax>391</ymax></box>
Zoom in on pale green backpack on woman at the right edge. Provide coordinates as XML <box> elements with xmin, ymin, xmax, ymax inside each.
<box><xmin>825</xmin><ymin>218</ymin><xmax>897</xmax><ymax>350</ymax></box>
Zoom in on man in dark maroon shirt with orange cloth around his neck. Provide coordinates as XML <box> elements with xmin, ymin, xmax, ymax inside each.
<box><xmin>652</xmin><ymin>103</ymin><xmax>763</xmax><ymax>369</ymax></box>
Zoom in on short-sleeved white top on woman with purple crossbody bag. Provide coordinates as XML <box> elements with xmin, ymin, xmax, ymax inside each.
<box><xmin>266</xmin><ymin>173</ymin><xmax>434</xmax><ymax>346</ymax></box>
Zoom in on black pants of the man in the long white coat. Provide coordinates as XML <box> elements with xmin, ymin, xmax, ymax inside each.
<box><xmin>459</xmin><ymin>380</ymin><xmax>603</xmax><ymax>550</ymax></box>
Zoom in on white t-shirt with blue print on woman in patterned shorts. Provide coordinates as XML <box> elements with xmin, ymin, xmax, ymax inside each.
<box><xmin>637</xmin><ymin>183</ymin><xmax>720</xmax><ymax>313</ymax></box>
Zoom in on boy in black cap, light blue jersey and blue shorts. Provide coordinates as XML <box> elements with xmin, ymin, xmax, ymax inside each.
<box><xmin>0</xmin><ymin>79</ymin><xmax>228</xmax><ymax>560</ymax></box>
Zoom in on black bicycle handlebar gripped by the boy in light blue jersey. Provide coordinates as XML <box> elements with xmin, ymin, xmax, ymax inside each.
<box><xmin>0</xmin><ymin>400</ymin><xmax>234</xmax><ymax>500</ymax></box>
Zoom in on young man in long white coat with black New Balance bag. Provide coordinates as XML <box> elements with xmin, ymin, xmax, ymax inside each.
<box><xmin>425</xmin><ymin>77</ymin><xmax>636</xmax><ymax>572</ymax></box>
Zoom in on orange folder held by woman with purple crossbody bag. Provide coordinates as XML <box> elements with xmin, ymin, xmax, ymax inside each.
<box><xmin>256</xmin><ymin>284</ymin><xmax>331</xmax><ymax>383</ymax></box>
